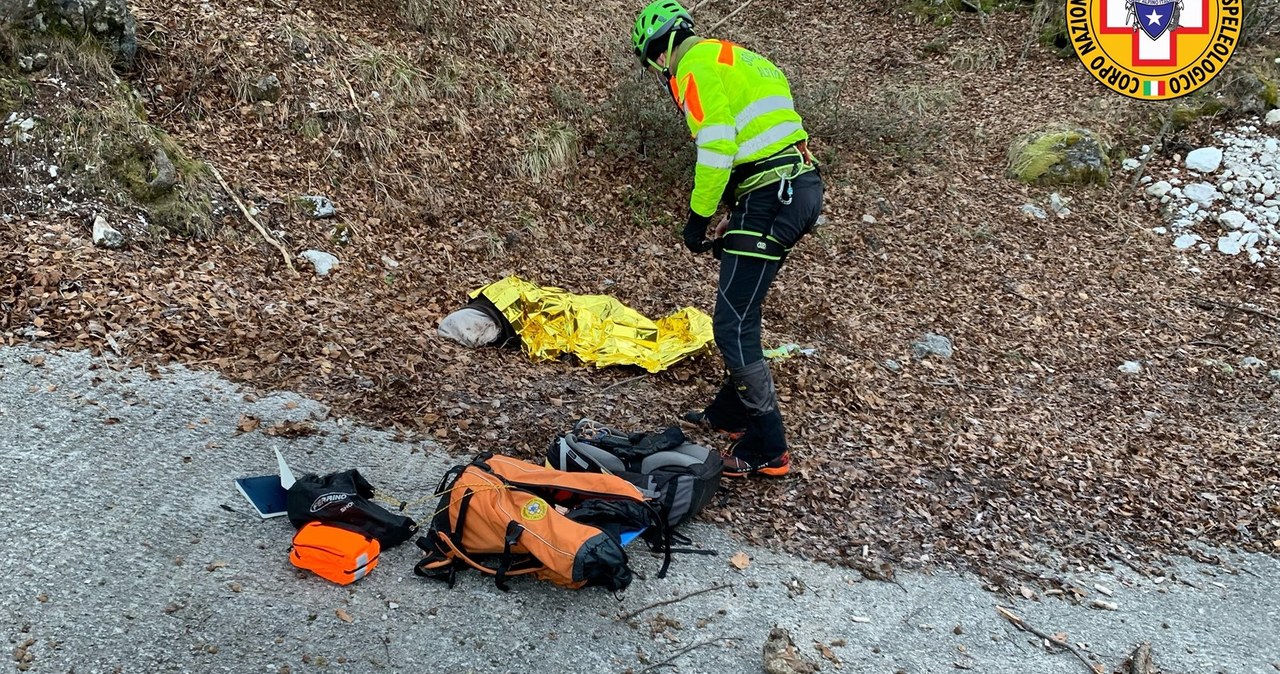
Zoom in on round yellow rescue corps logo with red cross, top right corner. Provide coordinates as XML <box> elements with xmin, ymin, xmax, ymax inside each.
<box><xmin>1066</xmin><ymin>0</ymin><xmax>1243</xmax><ymax>101</ymax></box>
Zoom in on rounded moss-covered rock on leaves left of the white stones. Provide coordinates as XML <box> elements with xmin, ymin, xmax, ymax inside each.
<box><xmin>1009</xmin><ymin>128</ymin><xmax>1111</xmax><ymax>185</ymax></box>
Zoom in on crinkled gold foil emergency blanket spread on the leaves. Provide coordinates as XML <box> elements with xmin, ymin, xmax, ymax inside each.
<box><xmin>471</xmin><ymin>276</ymin><xmax>713</xmax><ymax>372</ymax></box>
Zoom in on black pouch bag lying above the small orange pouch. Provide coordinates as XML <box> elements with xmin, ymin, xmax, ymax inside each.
<box><xmin>285</xmin><ymin>469</ymin><xmax>417</xmax><ymax>550</ymax></box>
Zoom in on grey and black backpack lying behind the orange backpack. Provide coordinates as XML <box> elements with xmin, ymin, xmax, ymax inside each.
<box><xmin>547</xmin><ymin>419</ymin><xmax>723</xmax><ymax>527</ymax></box>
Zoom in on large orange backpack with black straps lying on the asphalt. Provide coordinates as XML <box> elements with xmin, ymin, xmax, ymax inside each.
<box><xmin>413</xmin><ymin>454</ymin><xmax>669</xmax><ymax>591</ymax></box>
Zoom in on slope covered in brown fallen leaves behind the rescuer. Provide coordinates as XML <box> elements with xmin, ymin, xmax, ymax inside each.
<box><xmin>0</xmin><ymin>0</ymin><xmax>1280</xmax><ymax>585</ymax></box>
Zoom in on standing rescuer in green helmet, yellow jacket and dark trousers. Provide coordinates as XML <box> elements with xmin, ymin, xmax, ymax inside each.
<box><xmin>631</xmin><ymin>0</ymin><xmax>823</xmax><ymax>477</ymax></box>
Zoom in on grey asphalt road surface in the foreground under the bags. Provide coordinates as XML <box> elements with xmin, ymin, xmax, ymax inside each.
<box><xmin>0</xmin><ymin>348</ymin><xmax>1280</xmax><ymax>674</ymax></box>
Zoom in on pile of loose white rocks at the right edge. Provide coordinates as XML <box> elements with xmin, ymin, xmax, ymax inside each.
<box><xmin>1143</xmin><ymin>116</ymin><xmax>1280</xmax><ymax>266</ymax></box>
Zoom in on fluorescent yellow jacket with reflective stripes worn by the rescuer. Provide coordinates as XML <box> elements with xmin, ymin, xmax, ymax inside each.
<box><xmin>671</xmin><ymin>40</ymin><xmax>809</xmax><ymax>217</ymax></box>
